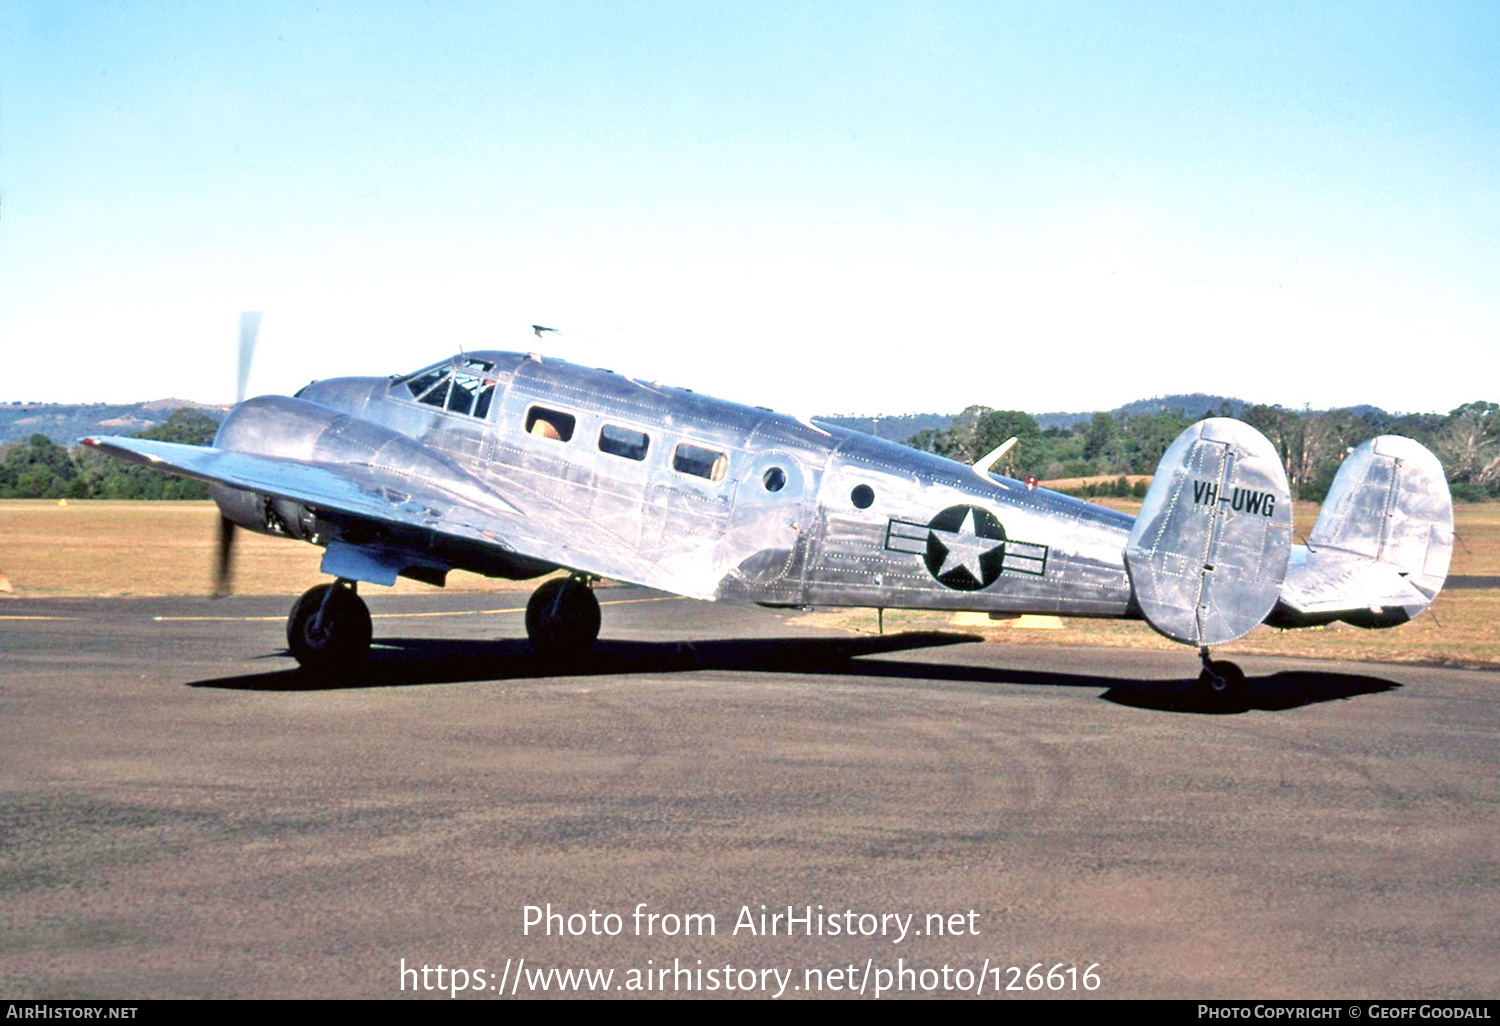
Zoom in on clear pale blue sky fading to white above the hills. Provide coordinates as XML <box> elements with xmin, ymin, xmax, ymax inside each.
<box><xmin>0</xmin><ymin>0</ymin><xmax>1500</xmax><ymax>414</ymax></box>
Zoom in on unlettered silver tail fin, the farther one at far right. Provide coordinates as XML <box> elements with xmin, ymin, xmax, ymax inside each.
<box><xmin>1266</xmin><ymin>435</ymin><xmax>1454</xmax><ymax>627</ymax></box>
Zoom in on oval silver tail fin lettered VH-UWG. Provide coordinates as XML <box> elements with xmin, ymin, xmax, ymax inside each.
<box><xmin>1125</xmin><ymin>417</ymin><xmax>1292</xmax><ymax>647</ymax></box>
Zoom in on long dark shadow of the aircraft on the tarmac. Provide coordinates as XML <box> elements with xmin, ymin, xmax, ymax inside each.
<box><xmin>188</xmin><ymin>632</ymin><xmax>1401</xmax><ymax>713</ymax></box>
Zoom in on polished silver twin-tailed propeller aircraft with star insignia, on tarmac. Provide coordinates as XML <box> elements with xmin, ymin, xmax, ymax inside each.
<box><xmin>84</xmin><ymin>326</ymin><xmax>1454</xmax><ymax>705</ymax></box>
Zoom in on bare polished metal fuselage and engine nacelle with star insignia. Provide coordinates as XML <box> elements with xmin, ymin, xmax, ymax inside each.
<box><xmin>215</xmin><ymin>353</ymin><xmax>1133</xmax><ymax>617</ymax></box>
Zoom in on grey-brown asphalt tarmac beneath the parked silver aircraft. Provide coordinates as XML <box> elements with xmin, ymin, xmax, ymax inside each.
<box><xmin>0</xmin><ymin>588</ymin><xmax>1500</xmax><ymax>1001</ymax></box>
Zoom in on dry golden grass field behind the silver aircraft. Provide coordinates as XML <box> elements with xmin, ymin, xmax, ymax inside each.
<box><xmin>0</xmin><ymin>500</ymin><xmax>1500</xmax><ymax>666</ymax></box>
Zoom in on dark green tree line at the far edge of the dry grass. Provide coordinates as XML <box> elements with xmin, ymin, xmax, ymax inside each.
<box><xmin>0</xmin><ymin>402</ymin><xmax>1500</xmax><ymax>503</ymax></box>
